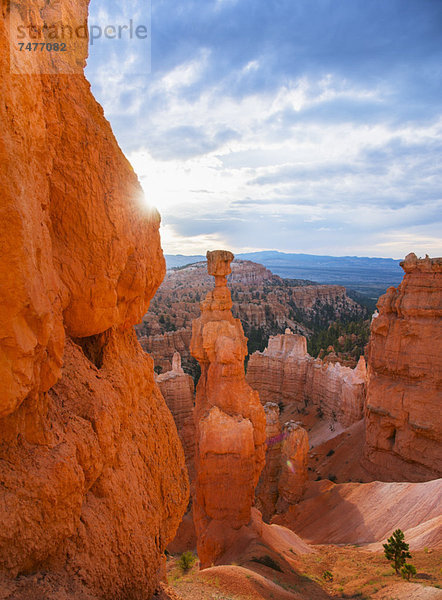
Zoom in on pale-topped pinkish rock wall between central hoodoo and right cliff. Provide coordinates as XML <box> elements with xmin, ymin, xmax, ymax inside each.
<box><xmin>247</xmin><ymin>331</ymin><xmax>366</xmax><ymax>427</ymax></box>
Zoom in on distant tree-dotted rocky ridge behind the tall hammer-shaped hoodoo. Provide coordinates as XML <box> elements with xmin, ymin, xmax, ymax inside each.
<box><xmin>137</xmin><ymin>261</ymin><xmax>365</xmax><ymax>373</ymax></box>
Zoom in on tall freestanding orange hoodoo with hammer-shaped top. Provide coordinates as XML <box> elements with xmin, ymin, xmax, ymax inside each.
<box><xmin>191</xmin><ymin>251</ymin><xmax>266</xmax><ymax>568</ymax></box>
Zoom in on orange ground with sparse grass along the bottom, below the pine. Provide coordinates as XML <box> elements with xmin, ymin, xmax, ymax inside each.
<box><xmin>166</xmin><ymin>545</ymin><xmax>442</xmax><ymax>600</ymax></box>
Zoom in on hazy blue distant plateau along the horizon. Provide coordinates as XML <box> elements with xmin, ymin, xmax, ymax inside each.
<box><xmin>165</xmin><ymin>250</ymin><xmax>403</xmax><ymax>298</ymax></box>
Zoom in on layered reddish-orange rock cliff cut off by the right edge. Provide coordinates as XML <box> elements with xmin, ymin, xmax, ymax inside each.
<box><xmin>364</xmin><ymin>254</ymin><xmax>442</xmax><ymax>481</ymax></box>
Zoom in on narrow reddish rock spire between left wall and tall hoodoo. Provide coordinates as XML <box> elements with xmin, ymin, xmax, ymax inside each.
<box><xmin>156</xmin><ymin>352</ymin><xmax>195</xmax><ymax>481</ymax></box>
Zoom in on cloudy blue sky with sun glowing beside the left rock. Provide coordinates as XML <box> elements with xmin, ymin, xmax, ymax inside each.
<box><xmin>87</xmin><ymin>0</ymin><xmax>442</xmax><ymax>258</ymax></box>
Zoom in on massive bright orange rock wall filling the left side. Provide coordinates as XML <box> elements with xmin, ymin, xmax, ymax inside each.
<box><xmin>0</xmin><ymin>0</ymin><xmax>188</xmax><ymax>599</ymax></box>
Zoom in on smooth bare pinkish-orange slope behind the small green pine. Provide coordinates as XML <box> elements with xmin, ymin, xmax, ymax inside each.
<box><xmin>274</xmin><ymin>479</ymin><xmax>442</xmax><ymax>551</ymax></box>
